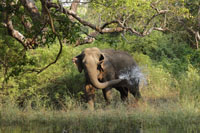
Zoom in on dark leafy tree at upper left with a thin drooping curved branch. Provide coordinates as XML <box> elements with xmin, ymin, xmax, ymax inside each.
<box><xmin>0</xmin><ymin>0</ymin><xmax>79</xmax><ymax>73</ymax></box>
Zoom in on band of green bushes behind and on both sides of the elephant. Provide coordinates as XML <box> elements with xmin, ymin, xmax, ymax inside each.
<box><xmin>1</xmin><ymin>32</ymin><xmax>200</xmax><ymax>125</ymax></box>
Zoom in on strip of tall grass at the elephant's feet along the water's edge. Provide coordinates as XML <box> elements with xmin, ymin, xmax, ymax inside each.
<box><xmin>0</xmin><ymin>88</ymin><xmax>200</xmax><ymax>132</ymax></box>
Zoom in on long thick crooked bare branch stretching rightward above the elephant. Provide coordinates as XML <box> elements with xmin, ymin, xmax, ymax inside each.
<box><xmin>39</xmin><ymin>0</ymin><xmax>168</xmax><ymax>46</ymax></box>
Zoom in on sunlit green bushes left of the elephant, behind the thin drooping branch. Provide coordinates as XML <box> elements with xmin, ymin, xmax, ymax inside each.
<box><xmin>1</xmin><ymin>45</ymin><xmax>83</xmax><ymax>107</ymax></box>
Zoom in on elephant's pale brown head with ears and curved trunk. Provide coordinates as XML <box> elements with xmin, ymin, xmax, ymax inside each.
<box><xmin>73</xmin><ymin>47</ymin><xmax>122</xmax><ymax>89</ymax></box>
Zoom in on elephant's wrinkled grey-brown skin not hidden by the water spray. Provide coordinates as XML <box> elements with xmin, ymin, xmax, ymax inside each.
<box><xmin>73</xmin><ymin>47</ymin><xmax>141</xmax><ymax>109</ymax></box>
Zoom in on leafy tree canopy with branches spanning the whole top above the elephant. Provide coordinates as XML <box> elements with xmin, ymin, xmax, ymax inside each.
<box><xmin>0</xmin><ymin>0</ymin><xmax>200</xmax><ymax>73</ymax></box>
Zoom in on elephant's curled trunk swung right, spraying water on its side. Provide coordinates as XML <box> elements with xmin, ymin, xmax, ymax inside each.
<box><xmin>85</xmin><ymin>58</ymin><xmax>122</xmax><ymax>89</ymax></box>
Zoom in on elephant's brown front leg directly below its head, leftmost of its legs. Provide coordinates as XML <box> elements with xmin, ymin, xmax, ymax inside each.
<box><xmin>85</xmin><ymin>84</ymin><xmax>95</xmax><ymax>110</ymax></box>
